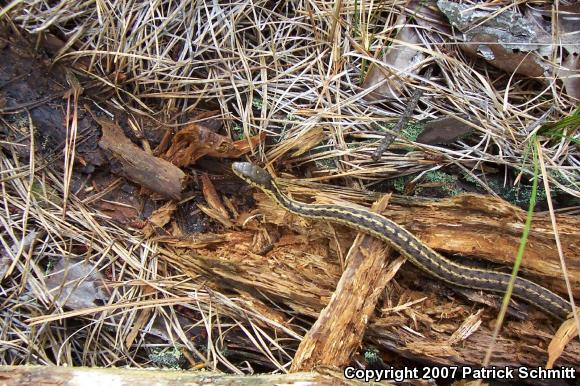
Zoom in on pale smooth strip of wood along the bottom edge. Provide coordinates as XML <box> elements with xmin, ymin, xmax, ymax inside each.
<box><xmin>0</xmin><ymin>366</ymin><xmax>362</xmax><ymax>386</ymax></box>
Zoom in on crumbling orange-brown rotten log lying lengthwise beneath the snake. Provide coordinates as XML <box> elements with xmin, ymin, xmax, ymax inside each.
<box><xmin>164</xmin><ymin>191</ymin><xmax>580</xmax><ymax>368</ymax></box>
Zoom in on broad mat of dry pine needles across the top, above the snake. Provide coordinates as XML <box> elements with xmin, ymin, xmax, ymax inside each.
<box><xmin>7</xmin><ymin>0</ymin><xmax>580</xmax><ymax>196</ymax></box>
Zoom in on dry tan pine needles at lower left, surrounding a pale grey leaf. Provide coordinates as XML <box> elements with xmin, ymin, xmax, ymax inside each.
<box><xmin>0</xmin><ymin>133</ymin><xmax>298</xmax><ymax>374</ymax></box>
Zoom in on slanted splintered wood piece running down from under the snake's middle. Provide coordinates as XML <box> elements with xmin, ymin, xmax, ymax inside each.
<box><xmin>290</xmin><ymin>196</ymin><xmax>400</xmax><ymax>372</ymax></box>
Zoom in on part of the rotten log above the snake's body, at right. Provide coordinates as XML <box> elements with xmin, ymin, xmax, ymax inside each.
<box><xmin>280</xmin><ymin>185</ymin><xmax>580</xmax><ymax>299</ymax></box>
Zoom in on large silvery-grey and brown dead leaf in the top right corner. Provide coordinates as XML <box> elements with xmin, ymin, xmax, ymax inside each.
<box><xmin>437</xmin><ymin>0</ymin><xmax>580</xmax><ymax>98</ymax></box>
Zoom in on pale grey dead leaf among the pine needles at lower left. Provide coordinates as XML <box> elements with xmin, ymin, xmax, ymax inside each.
<box><xmin>46</xmin><ymin>258</ymin><xmax>109</xmax><ymax>310</ymax></box>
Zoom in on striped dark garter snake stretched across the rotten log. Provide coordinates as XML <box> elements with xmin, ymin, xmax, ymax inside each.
<box><xmin>232</xmin><ymin>162</ymin><xmax>572</xmax><ymax>320</ymax></box>
